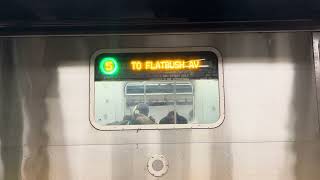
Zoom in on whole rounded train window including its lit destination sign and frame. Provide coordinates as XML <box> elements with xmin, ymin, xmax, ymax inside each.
<box><xmin>90</xmin><ymin>48</ymin><xmax>224</xmax><ymax>130</ymax></box>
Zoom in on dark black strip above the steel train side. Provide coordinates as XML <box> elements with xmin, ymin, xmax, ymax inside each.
<box><xmin>0</xmin><ymin>0</ymin><xmax>320</xmax><ymax>34</ymax></box>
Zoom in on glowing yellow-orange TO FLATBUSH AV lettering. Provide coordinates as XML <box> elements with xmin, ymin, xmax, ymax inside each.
<box><xmin>130</xmin><ymin>59</ymin><xmax>203</xmax><ymax>71</ymax></box>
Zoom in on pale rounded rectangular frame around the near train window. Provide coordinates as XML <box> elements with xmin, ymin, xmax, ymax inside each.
<box><xmin>89</xmin><ymin>47</ymin><xmax>225</xmax><ymax>131</ymax></box>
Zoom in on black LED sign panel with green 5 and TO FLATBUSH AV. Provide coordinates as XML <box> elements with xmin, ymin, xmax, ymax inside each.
<box><xmin>95</xmin><ymin>51</ymin><xmax>218</xmax><ymax>81</ymax></box>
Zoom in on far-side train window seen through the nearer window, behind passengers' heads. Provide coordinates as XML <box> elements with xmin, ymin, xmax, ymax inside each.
<box><xmin>124</xmin><ymin>81</ymin><xmax>194</xmax><ymax>124</ymax></box>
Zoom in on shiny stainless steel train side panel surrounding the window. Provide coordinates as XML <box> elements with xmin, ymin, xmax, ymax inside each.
<box><xmin>0</xmin><ymin>32</ymin><xmax>320</xmax><ymax>180</ymax></box>
